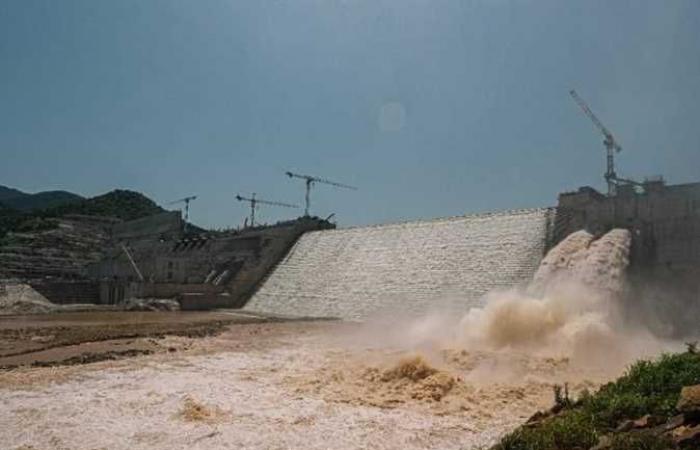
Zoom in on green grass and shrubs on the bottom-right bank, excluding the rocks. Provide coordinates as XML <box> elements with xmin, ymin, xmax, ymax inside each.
<box><xmin>495</xmin><ymin>352</ymin><xmax>700</xmax><ymax>450</ymax></box>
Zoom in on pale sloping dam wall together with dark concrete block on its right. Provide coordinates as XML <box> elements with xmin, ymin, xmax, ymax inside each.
<box><xmin>245</xmin><ymin>179</ymin><xmax>700</xmax><ymax>326</ymax></box>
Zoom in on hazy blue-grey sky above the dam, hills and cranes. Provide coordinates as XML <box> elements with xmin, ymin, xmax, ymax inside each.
<box><xmin>0</xmin><ymin>0</ymin><xmax>700</xmax><ymax>227</ymax></box>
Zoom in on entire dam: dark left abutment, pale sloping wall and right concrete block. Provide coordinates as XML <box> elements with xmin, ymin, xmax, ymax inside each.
<box><xmin>10</xmin><ymin>179</ymin><xmax>700</xmax><ymax>320</ymax></box>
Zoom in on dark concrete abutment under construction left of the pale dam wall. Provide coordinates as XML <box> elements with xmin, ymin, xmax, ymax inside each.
<box><xmin>90</xmin><ymin>213</ymin><xmax>334</xmax><ymax>309</ymax></box>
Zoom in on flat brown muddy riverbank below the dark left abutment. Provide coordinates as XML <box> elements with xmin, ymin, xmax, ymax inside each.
<box><xmin>0</xmin><ymin>311</ymin><xmax>272</xmax><ymax>369</ymax></box>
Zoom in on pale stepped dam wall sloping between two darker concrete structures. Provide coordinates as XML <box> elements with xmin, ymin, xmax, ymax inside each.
<box><xmin>245</xmin><ymin>209</ymin><xmax>553</xmax><ymax>320</ymax></box>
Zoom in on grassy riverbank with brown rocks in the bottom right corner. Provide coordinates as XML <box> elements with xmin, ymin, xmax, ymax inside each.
<box><xmin>493</xmin><ymin>344</ymin><xmax>700</xmax><ymax>450</ymax></box>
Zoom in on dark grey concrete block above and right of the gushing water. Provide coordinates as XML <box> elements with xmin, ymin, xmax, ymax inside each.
<box><xmin>553</xmin><ymin>179</ymin><xmax>700</xmax><ymax>326</ymax></box>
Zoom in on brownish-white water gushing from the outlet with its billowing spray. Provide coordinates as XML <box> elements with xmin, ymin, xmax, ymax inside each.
<box><xmin>459</xmin><ymin>229</ymin><xmax>662</xmax><ymax>370</ymax></box>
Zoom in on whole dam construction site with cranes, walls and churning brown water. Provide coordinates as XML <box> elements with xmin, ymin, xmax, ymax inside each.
<box><xmin>0</xmin><ymin>82</ymin><xmax>700</xmax><ymax>449</ymax></box>
